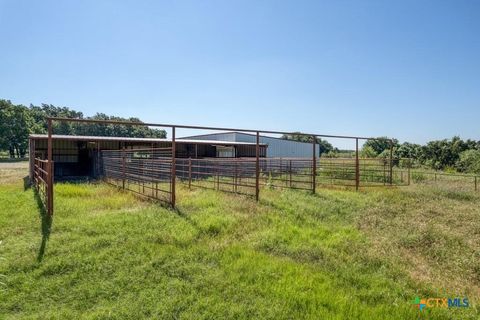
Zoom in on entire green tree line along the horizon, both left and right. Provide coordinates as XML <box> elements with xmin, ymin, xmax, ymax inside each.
<box><xmin>0</xmin><ymin>99</ymin><xmax>480</xmax><ymax>174</ymax></box>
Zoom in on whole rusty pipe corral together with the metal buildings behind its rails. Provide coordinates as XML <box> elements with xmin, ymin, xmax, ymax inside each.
<box><xmin>30</xmin><ymin>118</ymin><xmax>402</xmax><ymax>213</ymax></box>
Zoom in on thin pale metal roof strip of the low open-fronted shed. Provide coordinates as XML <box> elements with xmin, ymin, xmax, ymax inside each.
<box><xmin>29</xmin><ymin>134</ymin><xmax>266</xmax><ymax>146</ymax></box>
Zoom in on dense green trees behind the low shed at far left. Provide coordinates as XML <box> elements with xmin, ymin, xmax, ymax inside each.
<box><xmin>0</xmin><ymin>99</ymin><xmax>167</xmax><ymax>158</ymax></box>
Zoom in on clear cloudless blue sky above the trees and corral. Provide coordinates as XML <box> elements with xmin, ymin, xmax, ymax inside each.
<box><xmin>0</xmin><ymin>0</ymin><xmax>480</xmax><ymax>147</ymax></box>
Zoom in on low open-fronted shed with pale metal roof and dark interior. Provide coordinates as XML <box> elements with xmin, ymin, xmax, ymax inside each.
<box><xmin>29</xmin><ymin>134</ymin><xmax>267</xmax><ymax>180</ymax></box>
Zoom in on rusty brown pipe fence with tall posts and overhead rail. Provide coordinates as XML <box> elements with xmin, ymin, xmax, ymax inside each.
<box><xmin>37</xmin><ymin>117</ymin><xmax>400</xmax><ymax>215</ymax></box>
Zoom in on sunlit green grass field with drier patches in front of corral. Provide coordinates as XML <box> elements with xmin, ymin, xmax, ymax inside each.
<box><xmin>0</xmin><ymin>164</ymin><xmax>480</xmax><ymax>319</ymax></box>
